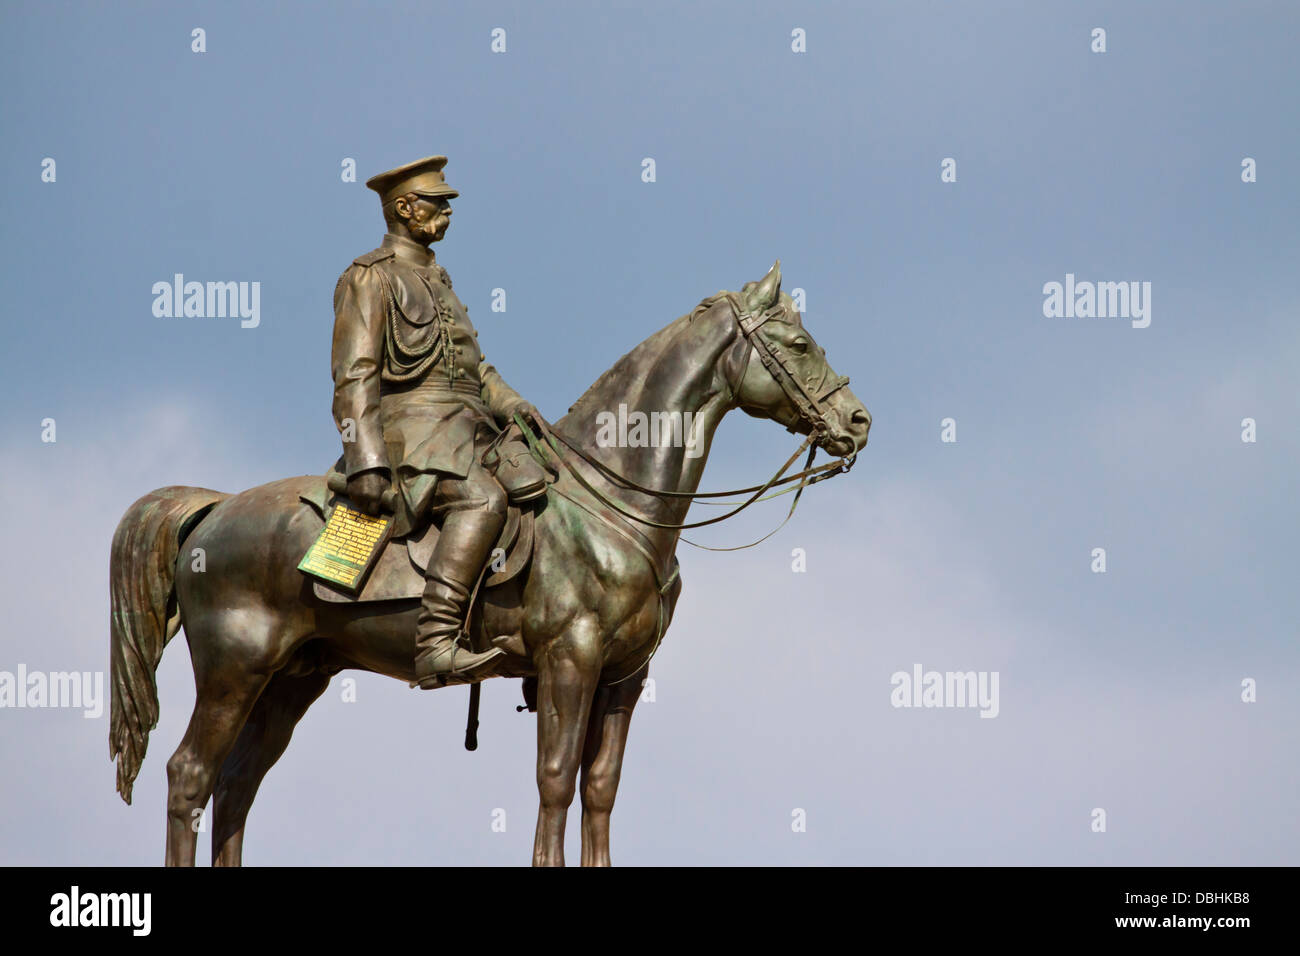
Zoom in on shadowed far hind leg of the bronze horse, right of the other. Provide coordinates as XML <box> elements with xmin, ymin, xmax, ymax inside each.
<box><xmin>212</xmin><ymin>671</ymin><xmax>329</xmax><ymax>866</ymax></box>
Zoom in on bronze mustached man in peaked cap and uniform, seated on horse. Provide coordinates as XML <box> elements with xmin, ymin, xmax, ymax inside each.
<box><xmin>332</xmin><ymin>156</ymin><xmax>546</xmax><ymax>688</ymax></box>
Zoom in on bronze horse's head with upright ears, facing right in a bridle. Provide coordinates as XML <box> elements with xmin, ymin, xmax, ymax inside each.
<box><xmin>732</xmin><ymin>260</ymin><xmax>871</xmax><ymax>457</ymax></box>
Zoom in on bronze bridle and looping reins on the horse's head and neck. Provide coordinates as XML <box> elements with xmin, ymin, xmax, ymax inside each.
<box><xmin>515</xmin><ymin>293</ymin><xmax>858</xmax><ymax>551</ymax></box>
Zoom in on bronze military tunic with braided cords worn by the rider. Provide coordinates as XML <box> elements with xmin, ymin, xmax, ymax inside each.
<box><xmin>332</xmin><ymin>233</ymin><xmax>524</xmax><ymax>535</ymax></box>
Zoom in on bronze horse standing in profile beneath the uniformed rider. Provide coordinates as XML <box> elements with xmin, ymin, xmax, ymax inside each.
<box><xmin>109</xmin><ymin>261</ymin><xmax>871</xmax><ymax>866</ymax></box>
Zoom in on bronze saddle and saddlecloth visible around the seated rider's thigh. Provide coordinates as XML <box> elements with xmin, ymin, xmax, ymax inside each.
<box><xmin>298</xmin><ymin>477</ymin><xmax>533</xmax><ymax>604</ymax></box>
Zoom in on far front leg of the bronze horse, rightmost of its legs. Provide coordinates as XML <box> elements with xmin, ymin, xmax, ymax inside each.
<box><xmin>582</xmin><ymin>662</ymin><xmax>650</xmax><ymax>866</ymax></box>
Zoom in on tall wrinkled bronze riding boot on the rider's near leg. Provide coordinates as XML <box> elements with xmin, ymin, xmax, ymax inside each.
<box><xmin>415</xmin><ymin>511</ymin><xmax>506</xmax><ymax>689</ymax></box>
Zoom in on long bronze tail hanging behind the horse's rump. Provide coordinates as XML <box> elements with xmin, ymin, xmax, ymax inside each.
<box><xmin>108</xmin><ymin>485</ymin><xmax>229</xmax><ymax>804</ymax></box>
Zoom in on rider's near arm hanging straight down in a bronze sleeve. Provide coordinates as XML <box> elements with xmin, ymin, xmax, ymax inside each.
<box><xmin>330</xmin><ymin>265</ymin><xmax>389</xmax><ymax>477</ymax></box>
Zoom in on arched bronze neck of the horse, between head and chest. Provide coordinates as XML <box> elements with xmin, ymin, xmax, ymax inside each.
<box><xmin>556</xmin><ymin>299</ymin><xmax>748</xmax><ymax>554</ymax></box>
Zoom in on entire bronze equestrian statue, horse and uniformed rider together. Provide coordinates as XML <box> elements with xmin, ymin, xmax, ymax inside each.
<box><xmin>109</xmin><ymin>157</ymin><xmax>871</xmax><ymax>865</ymax></box>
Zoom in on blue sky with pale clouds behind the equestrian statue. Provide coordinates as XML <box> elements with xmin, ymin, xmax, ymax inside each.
<box><xmin>0</xmin><ymin>3</ymin><xmax>1300</xmax><ymax>864</ymax></box>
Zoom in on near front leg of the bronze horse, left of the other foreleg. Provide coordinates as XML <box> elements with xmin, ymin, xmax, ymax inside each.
<box><xmin>533</xmin><ymin>620</ymin><xmax>601</xmax><ymax>866</ymax></box>
